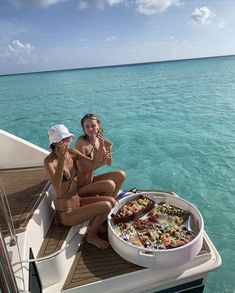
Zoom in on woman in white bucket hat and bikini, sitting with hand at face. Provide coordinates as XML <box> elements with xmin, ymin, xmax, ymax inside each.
<box><xmin>44</xmin><ymin>124</ymin><xmax>116</xmax><ymax>249</ymax></box>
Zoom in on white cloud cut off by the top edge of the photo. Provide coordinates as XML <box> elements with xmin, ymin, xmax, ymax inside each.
<box><xmin>136</xmin><ymin>0</ymin><xmax>179</xmax><ymax>15</ymax></box>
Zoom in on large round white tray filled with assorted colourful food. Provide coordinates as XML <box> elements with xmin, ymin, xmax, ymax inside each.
<box><xmin>108</xmin><ymin>190</ymin><xmax>204</xmax><ymax>269</ymax></box>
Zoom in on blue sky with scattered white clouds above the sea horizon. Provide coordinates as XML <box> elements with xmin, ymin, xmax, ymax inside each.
<box><xmin>0</xmin><ymin>0</ymin><xmax>235</xmax><ymax>74</ymax></box>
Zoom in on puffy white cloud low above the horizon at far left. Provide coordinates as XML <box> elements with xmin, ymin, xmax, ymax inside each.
<box><xmin>0</xmin><ymin>40</ymin><xmax>36</xmax><ymax>65</ymax></box>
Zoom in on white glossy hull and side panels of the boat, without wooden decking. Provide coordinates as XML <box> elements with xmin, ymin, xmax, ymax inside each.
<box><xmin>0</xmin><ymin>130</ymin><xmax>221</xmax><ymax>293</ymax></box>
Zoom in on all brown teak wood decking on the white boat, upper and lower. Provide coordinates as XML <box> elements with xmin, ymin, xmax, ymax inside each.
<box><xmin>0</xmin><ymin>167</ymin><xmax>210</xmax><ymax>290</ymax></box>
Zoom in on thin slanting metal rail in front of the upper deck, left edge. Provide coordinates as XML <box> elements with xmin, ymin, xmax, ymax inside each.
<box><xmin>0</xmin><ymin>178</ymin><xmax>16</xmax><ymax>246</ymax></box>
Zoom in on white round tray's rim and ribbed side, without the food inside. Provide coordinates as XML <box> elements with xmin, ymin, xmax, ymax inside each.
<box><xmin>108</xmin><ymin>191</ymin><xmax>204</xmax><ymax>268</ymax></box>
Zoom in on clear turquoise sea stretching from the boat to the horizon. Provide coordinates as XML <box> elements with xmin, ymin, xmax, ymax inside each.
<box><xmin>0</xmin><ymin>56</ymin><xmax>235</xmax><ymax>293</ymax></box>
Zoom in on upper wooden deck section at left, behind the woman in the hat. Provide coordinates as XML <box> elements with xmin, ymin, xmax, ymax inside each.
<box><xmin>0</xmin><ymin>166</ymin><xmax>49</xmax><ymax>236</ymax></box>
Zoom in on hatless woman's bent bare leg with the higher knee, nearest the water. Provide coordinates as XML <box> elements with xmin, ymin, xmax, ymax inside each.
<box><xmin>93</xmin><ymin>170</ymin><xmax>126</xmax><ymax>198</ymax></box>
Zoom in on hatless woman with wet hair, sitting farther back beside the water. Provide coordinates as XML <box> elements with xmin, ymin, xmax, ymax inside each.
<box><xmin>76</xmin><ymin>113</ymin><xmax>125</xmax><ymax>198</ymax></box>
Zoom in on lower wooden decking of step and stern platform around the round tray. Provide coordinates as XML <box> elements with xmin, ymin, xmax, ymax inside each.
<box><xmin>38</xmin><ymin>216</ymin><xmax>210</xmax><ymax>290</ymax></box>
